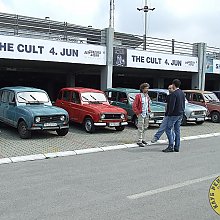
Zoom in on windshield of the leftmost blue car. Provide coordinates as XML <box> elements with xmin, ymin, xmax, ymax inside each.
<box><xmin>17</xmin><ymin>92</ymin><xmax>49</xmax><ymax>103</ymax></box>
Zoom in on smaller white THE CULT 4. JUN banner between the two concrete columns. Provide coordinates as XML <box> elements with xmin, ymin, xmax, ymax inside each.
<box><xmin>124</xmin><ymin>49</ymin><xmax>198</xmax><ymax>72</ymax></box>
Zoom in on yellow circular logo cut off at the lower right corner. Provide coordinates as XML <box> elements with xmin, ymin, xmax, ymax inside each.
<box><xmin>209</xmin><ymin>176</ymin><xmax>220</xmax><ymax>215</ymax></box>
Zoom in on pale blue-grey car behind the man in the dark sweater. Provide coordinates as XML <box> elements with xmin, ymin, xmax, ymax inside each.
<box><xmin>148</xmin><ymin>89</ymin><xmax>207</xmax><ymax>125</ymax></box>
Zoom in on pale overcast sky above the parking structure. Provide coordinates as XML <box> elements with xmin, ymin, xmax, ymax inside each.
<box><xmin>0</xmin><ymin>0</ymin><xmax>220</xmax><ymax>47</ymax></box>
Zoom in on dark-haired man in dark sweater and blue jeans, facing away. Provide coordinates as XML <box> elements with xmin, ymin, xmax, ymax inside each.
<box><xmin>163</xmin><ymin>79</ymin><xmax>185</xmax><ymax>153</ymax></box>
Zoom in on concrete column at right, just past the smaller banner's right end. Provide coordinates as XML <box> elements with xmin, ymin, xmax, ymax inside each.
<box><xmin>191</xmin><ymin>43</ymin><xmax>206</xmax><ymax>90</ymax></box>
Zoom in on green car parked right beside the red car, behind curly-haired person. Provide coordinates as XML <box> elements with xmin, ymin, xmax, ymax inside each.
<box><xmin>105</xmin><ymin>88</ymin><xmax>165</xmax><ymax>126</ymax></box>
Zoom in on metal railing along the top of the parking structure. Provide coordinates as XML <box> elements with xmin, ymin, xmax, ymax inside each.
<box><xmin>0</xmin><ymin>13</ymin><xmax>220</xmax><ymax>59</ymax></box>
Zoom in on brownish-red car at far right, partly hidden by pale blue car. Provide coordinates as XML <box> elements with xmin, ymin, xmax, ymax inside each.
<box><xmin>184</xmin><ymin>90</ymin><xmax>220</xmax><ymax>123</ymax></box>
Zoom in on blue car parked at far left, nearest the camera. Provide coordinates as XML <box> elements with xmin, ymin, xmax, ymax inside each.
<box><xmin>0</xmin><ymin>86</ymin><xmax>69</xmax><ymax>139</ymax></box>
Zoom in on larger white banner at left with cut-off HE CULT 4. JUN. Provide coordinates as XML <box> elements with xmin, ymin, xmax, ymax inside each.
<box><xmin>0</xmin><ymin>36</ymin><xmax>106</xmax><ymax>65</ymax></box>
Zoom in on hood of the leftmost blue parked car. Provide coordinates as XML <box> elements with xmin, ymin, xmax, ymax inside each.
<box><xmin>18</xmin><ymin>105</ymin><xmax>68</xmax><ymax>116</ymax></box>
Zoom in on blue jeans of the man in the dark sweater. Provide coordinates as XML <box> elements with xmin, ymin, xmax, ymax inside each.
<box><xmin>165</xmin><ymin>115</ymin><xmax>183</xmax><ymax>150</ymax></box>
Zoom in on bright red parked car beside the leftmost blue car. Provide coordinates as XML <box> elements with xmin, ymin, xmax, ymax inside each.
<box><xmin>55</xmin><ymin>88</ymin><xmax>128</xmax><ymax>133</ymax></box>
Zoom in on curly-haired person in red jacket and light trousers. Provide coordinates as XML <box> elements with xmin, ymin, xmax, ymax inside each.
<box><xmin>132</xmin><ymin>83</ymin><xmax>150</xmax><ymax>147</ymax></box>
